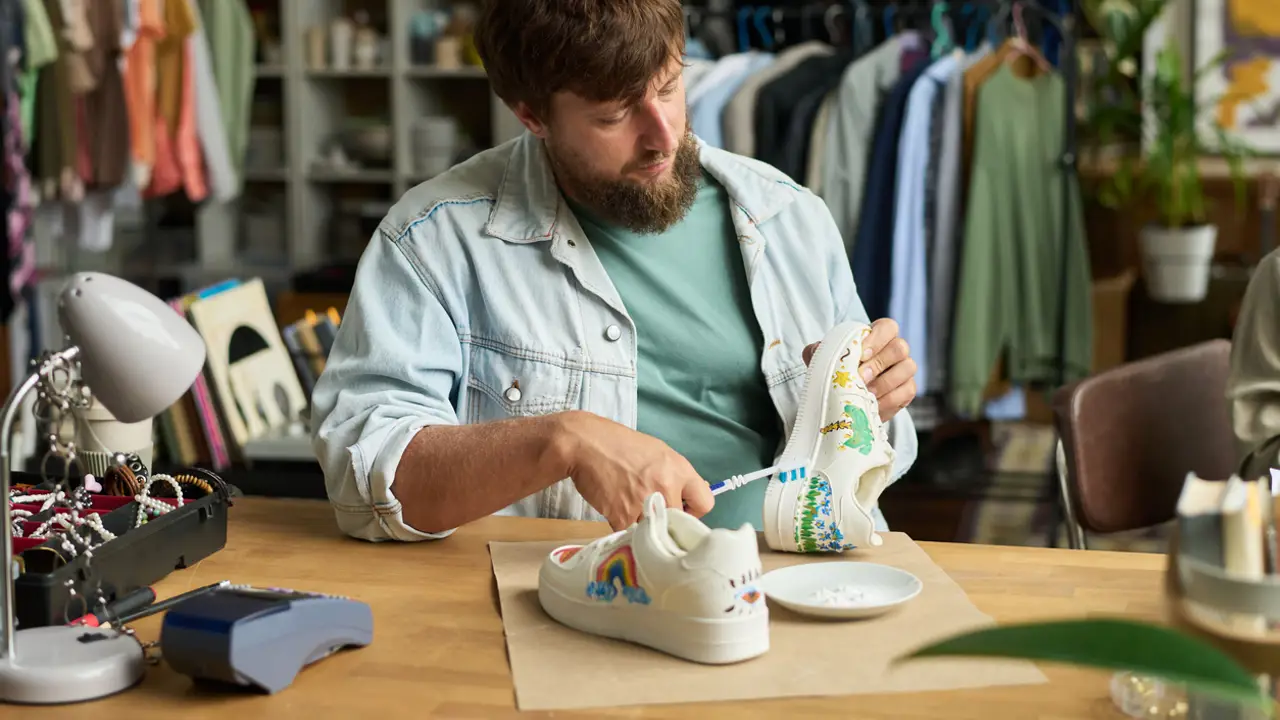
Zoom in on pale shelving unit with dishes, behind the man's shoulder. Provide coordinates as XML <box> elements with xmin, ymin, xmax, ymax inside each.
<box><xmin>193</xmin><ymin>0</ymin><xmax>521</xmax><ymax>281</ymax></box>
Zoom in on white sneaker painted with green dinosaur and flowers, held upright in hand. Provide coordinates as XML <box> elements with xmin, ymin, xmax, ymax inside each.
<box><xmin>763</xmin><ymin>323</ymin><xmax>893</xmax><ymax>552</ymax></box>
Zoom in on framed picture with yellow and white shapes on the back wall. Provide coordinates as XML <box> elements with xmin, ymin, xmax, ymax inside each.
<box><xmin>1192</xmin><ymin>0</ymin><xmax>1280</xmax><ymax>155</ymax></box>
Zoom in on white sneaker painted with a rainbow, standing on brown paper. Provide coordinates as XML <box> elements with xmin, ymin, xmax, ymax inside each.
<box><xmin>538</xmin><ymin>493</ymin><xmax>769</xmax><ymax>665</ymax></box>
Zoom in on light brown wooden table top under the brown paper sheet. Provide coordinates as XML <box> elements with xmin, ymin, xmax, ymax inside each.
<box><xmin>10</xmin><ymin>498</ymin><xmax>1164</xmax><ymax>720</ymax></box>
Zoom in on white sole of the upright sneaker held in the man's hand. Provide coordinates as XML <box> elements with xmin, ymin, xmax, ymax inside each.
<box><xmin>764</xmin><ymin>322</ymin><xmax>867</xmax><ymax>552</ymax></box>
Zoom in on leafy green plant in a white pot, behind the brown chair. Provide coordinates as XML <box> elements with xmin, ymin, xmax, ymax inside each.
<box><xmin>1085</xmin><ymin>0</ymin><xmax>1251</xmax><ymax>302</ymax></box>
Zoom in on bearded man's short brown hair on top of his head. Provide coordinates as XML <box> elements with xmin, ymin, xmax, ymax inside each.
<box><xmin>475</xmin><ymin>0</ymin><xmax>685</xmax><ymax>120</ymax></box>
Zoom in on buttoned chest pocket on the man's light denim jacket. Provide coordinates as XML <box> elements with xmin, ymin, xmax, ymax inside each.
<box><xmin>466</xmin><ymin>345</ymin><xmax>582</xmax><ymax>423</ymax></box>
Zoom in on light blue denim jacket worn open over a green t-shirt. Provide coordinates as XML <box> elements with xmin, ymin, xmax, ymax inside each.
<box><xmin>311</xmin><ymin>133</ymin><xmax>916</xmax><ymax>541</ymax></box>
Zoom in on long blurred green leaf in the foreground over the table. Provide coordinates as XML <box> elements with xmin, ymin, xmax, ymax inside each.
<box><xmin>895</xmin><ymin>619</ymin><xmax>1271</xmax><ymax>710</ymax></box>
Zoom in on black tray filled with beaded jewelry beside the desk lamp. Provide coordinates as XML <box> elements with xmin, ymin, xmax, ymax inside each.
<box><xmin>10</xmin><ymin>473</ymin><xmax>230</xmax><ymax>629</ymax></box>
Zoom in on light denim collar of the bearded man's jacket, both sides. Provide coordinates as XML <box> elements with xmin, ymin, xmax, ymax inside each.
<box><xmin>484</xmin><ymin>132</ymin><xmax>799</xmax><ymax>243</ymax></box>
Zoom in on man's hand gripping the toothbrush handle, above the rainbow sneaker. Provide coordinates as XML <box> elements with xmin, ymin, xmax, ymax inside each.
<box><xmin>558</xmin><ymin>411</ymin><xmax>716</xmax><ymax>530</ymax></box>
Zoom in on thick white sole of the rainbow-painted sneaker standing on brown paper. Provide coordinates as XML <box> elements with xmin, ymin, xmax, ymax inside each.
<box><xmin>538</xmin><ymin>571</ymin><xmax>769</xmax><ymax>665</ymax></box>
